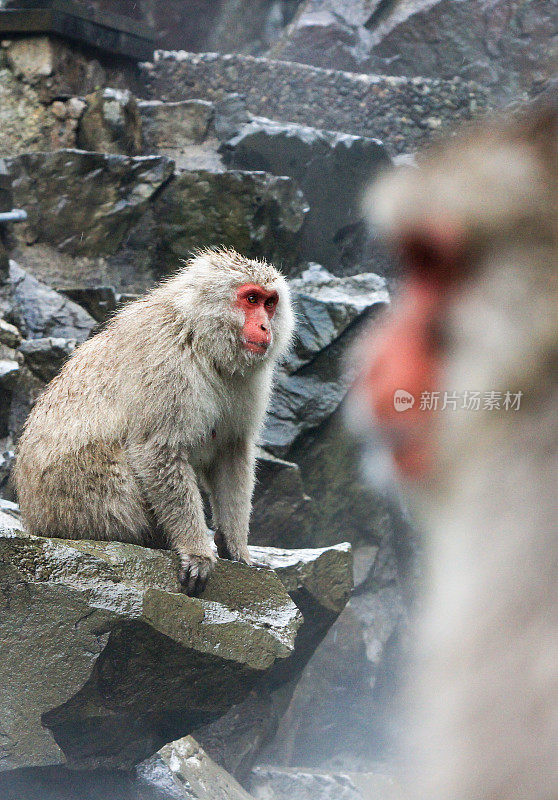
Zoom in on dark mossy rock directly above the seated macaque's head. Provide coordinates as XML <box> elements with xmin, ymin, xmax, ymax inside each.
<box><xmin>154</xmin><ymin>170</ymin><xmax>308</xmax><ymax>271</ymax></box>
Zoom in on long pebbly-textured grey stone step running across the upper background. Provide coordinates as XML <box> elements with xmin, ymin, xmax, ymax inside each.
<box><xmin>141</xmin><ymin>51</ymin><xmax>488</xmax><ymax>154</ymax></box>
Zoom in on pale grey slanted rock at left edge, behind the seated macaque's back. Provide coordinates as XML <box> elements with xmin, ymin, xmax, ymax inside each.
<box><xmin>4</xmin><ymin>261</ymin><xmax>95</xmax><ymax>342</ymax></box>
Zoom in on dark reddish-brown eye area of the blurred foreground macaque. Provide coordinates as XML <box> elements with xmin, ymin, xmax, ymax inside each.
<box><xmin>398</xmin><ymin>214</ymin><xmax>466</xmax><ymax>283</ymax></box>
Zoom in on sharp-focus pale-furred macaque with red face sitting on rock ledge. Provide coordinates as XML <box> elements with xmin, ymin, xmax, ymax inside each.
<box><xmin>15</xmin><ymin>249</ymin><xmax>293</xmax><ymax>594</ymax></box>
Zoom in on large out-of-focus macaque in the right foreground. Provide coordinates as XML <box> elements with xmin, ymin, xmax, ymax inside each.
<box><xmin>353</xmin><ymin>98</ymin><xmax>558</xmax><ymax>800</ymax></box>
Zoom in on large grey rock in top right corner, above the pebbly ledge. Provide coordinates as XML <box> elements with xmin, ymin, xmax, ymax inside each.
<box><xmin>271</xmin><ymin>0</ymin><xmax>556</xmax><ymax>95</ymax></box>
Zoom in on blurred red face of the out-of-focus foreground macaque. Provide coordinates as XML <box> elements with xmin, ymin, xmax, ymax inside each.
<box><xmin>356</xmin><ymin>220</ymin><xmax>463</xmax><ymax>480</ymax></box>
